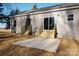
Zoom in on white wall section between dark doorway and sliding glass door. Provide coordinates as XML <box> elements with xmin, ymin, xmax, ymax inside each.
<box><xmin>30</xmin><ymin>13</ymin><xmax>52</xmax><ymax>34</ymax></box>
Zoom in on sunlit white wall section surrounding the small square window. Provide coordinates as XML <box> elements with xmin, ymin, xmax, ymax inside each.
<box><xmin>53</xmin><ymin>9</ymin><xmax>79</xmax><ymax>39</ymax></box>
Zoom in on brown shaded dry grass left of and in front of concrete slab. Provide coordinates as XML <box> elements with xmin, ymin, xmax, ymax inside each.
<box><xmin>0</xmin><ymin>29</ymin><xmax>55</xmax><ymax>56</ymax></box>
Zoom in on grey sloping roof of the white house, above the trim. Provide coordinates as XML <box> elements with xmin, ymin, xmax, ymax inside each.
<box><xmin>14</xmin><ymin>3</ymin><xmax>79</xmax><ymax>14</ymax></box>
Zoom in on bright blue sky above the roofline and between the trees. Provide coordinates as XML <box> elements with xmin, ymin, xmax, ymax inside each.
<box><xmin>0</xmin><ymin>3</ymin><xmax>59</xmax><ymax>28</ymax></box>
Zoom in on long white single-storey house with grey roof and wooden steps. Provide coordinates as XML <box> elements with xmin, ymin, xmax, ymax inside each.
<box><xmin>10</xmin><ymin>3</ymin><xmax>79</xmax><ymax>39</ymax></box>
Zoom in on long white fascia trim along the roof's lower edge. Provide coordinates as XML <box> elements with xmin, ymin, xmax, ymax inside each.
<box><xmin>13</xmin><ymin>6</ymin><xmax>79</xmax><ymax>17</ymax></box>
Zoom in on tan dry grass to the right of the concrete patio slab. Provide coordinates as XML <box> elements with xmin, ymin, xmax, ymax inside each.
<box><xmin>56</xmin><ymin>38</ymin><xmax>79</xmax><ymax>56</ymax></box>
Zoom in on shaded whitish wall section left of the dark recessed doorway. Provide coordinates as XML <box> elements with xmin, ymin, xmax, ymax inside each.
<box><xmin>10</xmin><ymin>16</ymin><xmax>27</xmax><ymax>34</ymax></box>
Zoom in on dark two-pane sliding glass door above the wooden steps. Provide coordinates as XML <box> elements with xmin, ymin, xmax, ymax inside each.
<box><xmin>44</xmin><ymin>17</ymin><xmax>54</xmax><ymax>30</ymax></box>
